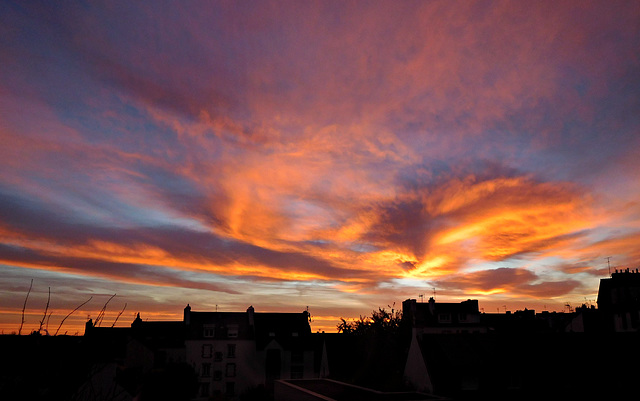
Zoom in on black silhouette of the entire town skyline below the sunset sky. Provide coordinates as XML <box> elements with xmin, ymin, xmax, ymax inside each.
<box><xmin>0</xmin><ymin>269</ymin><xmax>640</xmax><ymax>401</ymax></box>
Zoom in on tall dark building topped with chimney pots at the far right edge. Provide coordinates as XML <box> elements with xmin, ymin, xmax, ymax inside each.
<box><xmin>598</xmin><ymin>269</ymin><xmax>640</xmax><ymax>332</ymax></box>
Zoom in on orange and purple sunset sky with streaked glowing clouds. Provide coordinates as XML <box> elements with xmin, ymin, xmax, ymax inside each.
<box><xmin>0</xmin><ymin>0</ymin><xmax>640</xmax><ymax>334</ymax></box>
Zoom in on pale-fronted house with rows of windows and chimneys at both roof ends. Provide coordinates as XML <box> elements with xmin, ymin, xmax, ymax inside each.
<box><xmin>184</xmin><ymin>305</ymin><xmax>315</xmax><ymax>398</ymax></box>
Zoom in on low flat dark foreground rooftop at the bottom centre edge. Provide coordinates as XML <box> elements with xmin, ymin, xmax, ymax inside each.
<box><xmin>275</xmin><ymin>379</ymin><xmax>442</xmax><ymax>401</ymax></box>
